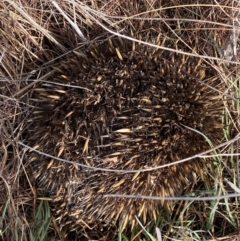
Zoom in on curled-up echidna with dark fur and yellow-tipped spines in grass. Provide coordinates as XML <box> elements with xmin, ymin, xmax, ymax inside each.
<box><xmin>29</xmin><ymin>35</ymin><xmax>223</xmax><ymax>235</ymax></box>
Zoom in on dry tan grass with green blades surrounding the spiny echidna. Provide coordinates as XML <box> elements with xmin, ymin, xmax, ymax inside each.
<box><xmin>0</xmin><ymin>0</ymin><xmax>240</xmax><ymax>241</ymax></box>
